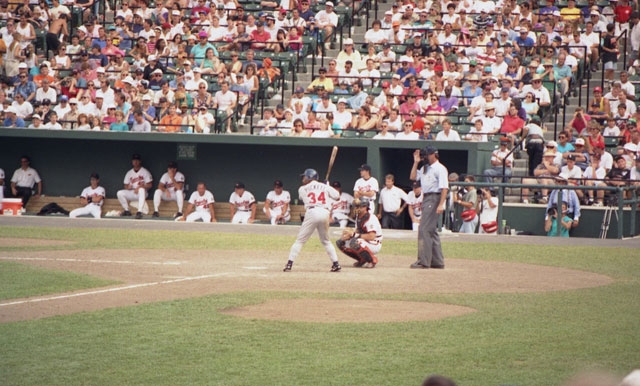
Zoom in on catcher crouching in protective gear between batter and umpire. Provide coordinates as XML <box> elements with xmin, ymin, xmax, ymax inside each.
<box><xmin>336</xmin><ymin>198</ymin><xmax>382</xmax><ymax>268</ymax></box>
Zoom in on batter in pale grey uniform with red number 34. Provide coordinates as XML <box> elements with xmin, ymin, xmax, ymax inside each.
<box><xmin>284</xmin><ymin>169</ymin><xmax>342</xmax><ymax>272</ymax></box>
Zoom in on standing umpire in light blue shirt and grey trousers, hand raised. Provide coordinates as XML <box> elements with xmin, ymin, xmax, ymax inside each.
<box><xmin>410</xmin><ymin>146</ymin><xmax>449</xmax><ymax>269</ymax></box>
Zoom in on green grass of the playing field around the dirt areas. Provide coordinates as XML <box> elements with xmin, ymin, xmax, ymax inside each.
<box><xmin>0</xmin><ymin>227</ymin><xmax>640</xmax><ymax>386</ymax></box>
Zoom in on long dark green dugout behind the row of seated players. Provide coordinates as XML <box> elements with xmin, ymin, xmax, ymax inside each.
<box><xmin>0</xmin><ymin>129</ymin><xmax>494</xmax><ymax>201</ymax></box>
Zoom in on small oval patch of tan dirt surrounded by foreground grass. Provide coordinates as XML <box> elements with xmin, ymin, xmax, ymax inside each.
<box><xmin>222</xmin><ymin>299</ymin><xmax>475</xmax><ymax>323</ymax></box>
